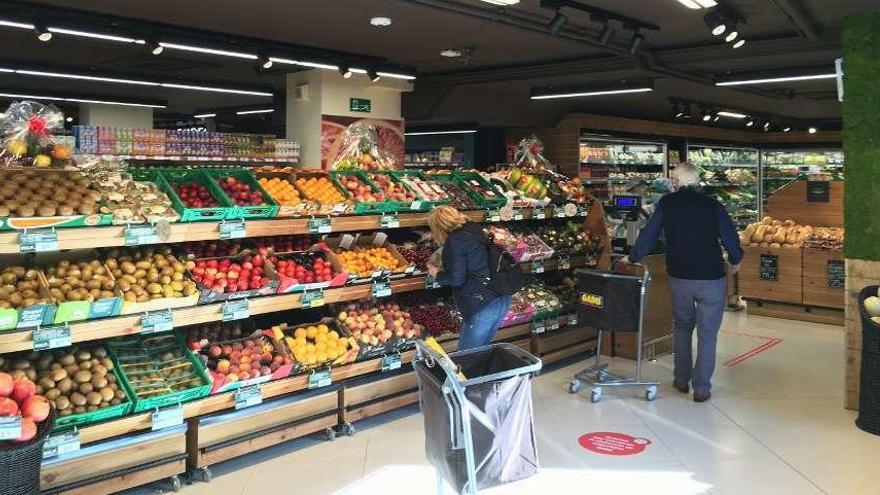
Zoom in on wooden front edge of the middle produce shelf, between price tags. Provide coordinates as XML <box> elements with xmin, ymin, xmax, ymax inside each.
<box><xmin>0</xmin><ymin>276</ymin><xmax>425</xmax><ymax>354</ymax></box>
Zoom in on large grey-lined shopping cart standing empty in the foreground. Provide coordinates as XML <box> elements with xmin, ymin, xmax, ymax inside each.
<box><xmin>413</xmin><ymin>341</ymin><xmax>541</xmax><ymax>494</ymax></box>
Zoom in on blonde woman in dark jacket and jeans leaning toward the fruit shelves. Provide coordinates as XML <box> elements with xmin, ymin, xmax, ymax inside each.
<box><xmin>428</xmin><ymin>206</ymin><xmax>511</xmax><ymax>351</ymax></box>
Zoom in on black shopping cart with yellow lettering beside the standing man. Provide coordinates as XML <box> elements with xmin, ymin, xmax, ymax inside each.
<box><xmin>569</xmin><ymin>264</ymin><xmax>659</xmax><ymax>403</ymax></box>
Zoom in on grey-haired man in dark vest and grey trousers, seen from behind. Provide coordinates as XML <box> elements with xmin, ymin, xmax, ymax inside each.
<box><xmin>623</xmin><ymin>163</ymin><xmax>743</xmax><ymax>402</ymax></box>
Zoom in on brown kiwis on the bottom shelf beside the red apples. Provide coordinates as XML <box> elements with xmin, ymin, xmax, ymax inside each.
<box><xmin>0</xmin><ymin>346</ymin><xmax>128</xmax><ymax>417</ymax></box>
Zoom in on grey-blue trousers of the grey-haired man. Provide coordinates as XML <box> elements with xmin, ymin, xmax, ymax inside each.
<box><xmin>669</xmin><ymin>277</ymin><xmax>727</xmax><ymax>394</ymax></box>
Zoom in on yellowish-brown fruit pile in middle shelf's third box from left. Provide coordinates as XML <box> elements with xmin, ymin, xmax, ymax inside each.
<box><xmin>104</xmin><ymin>246</ymin><xmax>198</xmax><ymax>302</ymax></box>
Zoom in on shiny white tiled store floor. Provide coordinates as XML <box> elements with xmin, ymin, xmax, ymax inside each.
<box><xmin>141</xmin><ymin>314</ymin><xmax>880</xmax><ymax>495</ymax></box>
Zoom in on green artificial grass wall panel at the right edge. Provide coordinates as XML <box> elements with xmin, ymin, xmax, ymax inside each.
<box><xmin>843</xmin><ymin>11</ymin><xmax>880</xmax><ymax>261</ymax></box>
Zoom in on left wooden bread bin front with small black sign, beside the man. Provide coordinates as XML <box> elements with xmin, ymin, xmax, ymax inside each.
<box><xmin>738</xmin><ymin>246</ymin><xmax>804</xmax><ymax>304</ymax></box>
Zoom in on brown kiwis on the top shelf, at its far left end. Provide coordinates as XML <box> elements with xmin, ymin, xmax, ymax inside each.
<box><xmin>0</xmin><ymin>170</ymin><xmax>101</xmax><ymax>217</ymax></box>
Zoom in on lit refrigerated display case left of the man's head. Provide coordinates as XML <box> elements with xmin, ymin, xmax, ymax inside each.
<box><xmin>579</xmin><ymin>134</ymin><xmax>667</xmax><ymax>200</ymax></box>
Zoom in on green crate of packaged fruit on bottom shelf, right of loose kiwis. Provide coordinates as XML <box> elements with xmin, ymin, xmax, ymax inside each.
<box><xmin>108</xmin><ymin>332</ymin><xmax>211</xmax><ymax>413</ymax></box>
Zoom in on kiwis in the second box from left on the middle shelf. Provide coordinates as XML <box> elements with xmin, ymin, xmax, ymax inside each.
<box><xmin>46</xmin><ymin>259</ymin><xmax>116</xmax><ymax>303</ymax></box>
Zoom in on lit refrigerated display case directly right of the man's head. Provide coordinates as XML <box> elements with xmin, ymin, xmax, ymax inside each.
<box><xmin>687</xmin><ymin>145</ymin><xmax>760</xmax><ymax>229</ymax></box>
